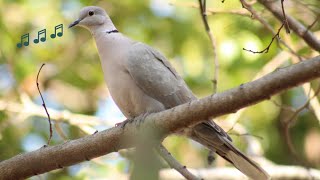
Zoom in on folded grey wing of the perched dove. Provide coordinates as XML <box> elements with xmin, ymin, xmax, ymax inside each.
<box><xmin>126</xmin><ymin>42</ymin><xmax>196</xmax><ymax>108</ymax></box>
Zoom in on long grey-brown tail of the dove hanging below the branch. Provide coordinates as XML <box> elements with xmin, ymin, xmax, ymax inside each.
<box><xmin>189</xmin><ymin>122</ymin><xmax>270</xmax><ymax>180</ymax></box>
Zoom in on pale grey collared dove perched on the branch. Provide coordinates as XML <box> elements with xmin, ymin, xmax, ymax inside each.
<box><xmin>69</xmin><ymin>6</ymin><xmax>269</xmax><ymax>180</ymax></box>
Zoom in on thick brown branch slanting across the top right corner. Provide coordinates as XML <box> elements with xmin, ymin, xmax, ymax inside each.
<box><xmin>258</xmin><ymin>0</ymin><xmax>320</xmax><ymax>52</ymax></box>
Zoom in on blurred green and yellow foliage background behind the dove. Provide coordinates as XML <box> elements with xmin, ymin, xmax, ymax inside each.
<box><xmin>0</xmin><ymin>0</ymin><xmax>320</xmax><ymax>179</ymax></box>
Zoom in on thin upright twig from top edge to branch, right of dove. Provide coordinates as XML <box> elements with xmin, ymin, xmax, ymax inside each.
<box><xmin>199</xmin><ymin>0</ymin><xmax>219</xmax><ymax>93</ymax></box>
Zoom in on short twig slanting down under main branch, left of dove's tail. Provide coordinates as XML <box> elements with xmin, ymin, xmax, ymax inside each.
<box><xmin>156</xmin><ymin>144</ymin><xmax>200</xmax><ymax>179</ymax></box>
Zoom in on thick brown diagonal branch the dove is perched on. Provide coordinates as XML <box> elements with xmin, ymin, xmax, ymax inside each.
<box><xmin>0</xmin><ymin>56</ymin><xmax>320</xmax><ymax>179</ymax></box>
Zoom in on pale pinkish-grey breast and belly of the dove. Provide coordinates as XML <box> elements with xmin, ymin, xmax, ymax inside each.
<box><xmin>100</xmin><ymin>44</ymin><xmax>165</xmax><ymax>118</ymax></box>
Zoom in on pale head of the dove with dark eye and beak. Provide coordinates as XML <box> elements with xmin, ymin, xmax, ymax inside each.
<box><xmin>69</xmin><ymin>6</ymin><xmax>114</xmax><ymax>32</ymax></box>
